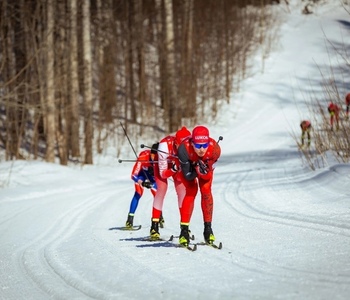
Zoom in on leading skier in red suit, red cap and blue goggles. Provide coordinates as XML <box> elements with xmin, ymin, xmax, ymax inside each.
<box><xmin>178</xmin><ymin>126</ymin><xmax>221</xmax><ymax>246</ymax></box>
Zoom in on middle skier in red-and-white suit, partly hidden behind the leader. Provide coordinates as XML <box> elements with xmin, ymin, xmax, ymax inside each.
<box><xmin>150</xmin><ymin>127</ymin><xmax>191</xmax><ymax>240</ymax></box>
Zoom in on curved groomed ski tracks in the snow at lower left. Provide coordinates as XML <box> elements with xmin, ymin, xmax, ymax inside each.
<box><xmin>16</xmin><ymin>191</ymin><xmax>116</xmax><ymax>299</ymax></box>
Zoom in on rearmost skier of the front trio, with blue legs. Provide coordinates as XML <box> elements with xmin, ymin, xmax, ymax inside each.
<box><xmin>125</xmin><ymin>150</ymin><xmax>157</xmax><ymax>228</ymax></box>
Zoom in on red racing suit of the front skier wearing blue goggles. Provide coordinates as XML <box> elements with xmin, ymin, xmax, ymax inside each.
<box><xmin>178</xmin><ymin>138</ymin><xmax>221</xmax><ymax>225</ymax></box>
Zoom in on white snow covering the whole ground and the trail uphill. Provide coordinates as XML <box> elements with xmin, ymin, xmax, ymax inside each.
<box><xmin>0</xmin><ymin>1</ymin><xmax>350</xmax><ymax>300</ymax></box>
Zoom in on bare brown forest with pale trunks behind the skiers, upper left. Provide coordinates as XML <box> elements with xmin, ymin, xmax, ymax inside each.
<box><xmin>0</xmin><ymin>0</ymin><xmax>282</xmax><ymax>165</ymax></box>
